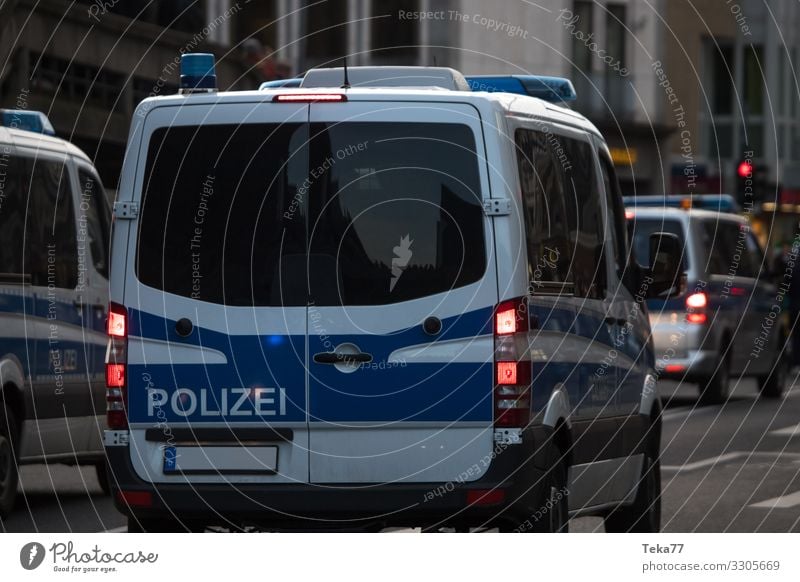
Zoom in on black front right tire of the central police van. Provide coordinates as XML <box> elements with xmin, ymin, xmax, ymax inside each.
<box><xmin>605</xmin><ymin>451</ymin><xmax>661</xmax><ymax>533</ymax></box>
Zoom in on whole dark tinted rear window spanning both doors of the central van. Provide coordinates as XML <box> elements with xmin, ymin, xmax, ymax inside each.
<box><xmin>136</xmin><ymin>122</ymin><xmax>486</xmax><ymax>306</ymax></box>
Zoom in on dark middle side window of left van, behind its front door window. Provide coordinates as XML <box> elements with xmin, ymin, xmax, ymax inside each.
<box><xmin>22</xmin><ymin>158</ymin><xmax>78</xmax><ymax>289</ymax></box>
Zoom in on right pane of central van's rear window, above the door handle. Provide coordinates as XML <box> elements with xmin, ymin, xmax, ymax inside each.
<box><xmin>309</xmin><ymin>123</ymin><xmax>486</xmax><ymax>305</ymax></box>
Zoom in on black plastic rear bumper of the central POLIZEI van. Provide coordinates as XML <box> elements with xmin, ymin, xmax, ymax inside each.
<box><xmin>106</xmin><ymin>427</ymin><xmax>552</xmax><ymax>529</ymax></box>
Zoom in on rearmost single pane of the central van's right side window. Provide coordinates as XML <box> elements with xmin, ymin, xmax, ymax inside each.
<box><xmin>515</xmin><ymin>129</ymin><xmax>574</xmax><ymax>293</ymax></box>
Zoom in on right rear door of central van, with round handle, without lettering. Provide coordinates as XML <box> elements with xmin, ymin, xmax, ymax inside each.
<box><xmin>301</xmin><ymin>100</ymin><xmax>497</xmax><ymax>483</ymax></box>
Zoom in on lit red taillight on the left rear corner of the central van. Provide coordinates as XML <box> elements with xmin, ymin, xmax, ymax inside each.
<box><xmin>106</xmin><ymin>303</ymin><xmax>128</xmax><ymax>430</ymax></box>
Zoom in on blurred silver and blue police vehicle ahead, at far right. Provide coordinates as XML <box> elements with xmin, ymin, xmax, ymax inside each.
<box><xmin>626</xmin><ymin>205</ymin><xmax>789</xmax><ymax>403</ymax></box>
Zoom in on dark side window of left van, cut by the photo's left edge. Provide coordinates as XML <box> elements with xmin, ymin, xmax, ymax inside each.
<box><xmin>0</xmin><ymin>152</ymin><xmax>30</xmax><ymax>283</ymax></box>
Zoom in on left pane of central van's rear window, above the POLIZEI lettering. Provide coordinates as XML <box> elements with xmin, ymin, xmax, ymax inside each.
<box><xmin>136</xmin><ymin>123</ymin><xmax>308</xmax><ymax>305</ymax></box>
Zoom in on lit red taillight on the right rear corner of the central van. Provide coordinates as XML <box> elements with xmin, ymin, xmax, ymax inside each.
<box><xmin>494</xmin><ymin>298</ymin><xmax>531</xmax><ymax>428</ymax></box>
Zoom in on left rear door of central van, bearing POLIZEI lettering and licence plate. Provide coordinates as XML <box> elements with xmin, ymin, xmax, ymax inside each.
<box><xmin>126</xmin><ymin>103</ymin><xmax>308</xmax><ymax>483</ymax></box>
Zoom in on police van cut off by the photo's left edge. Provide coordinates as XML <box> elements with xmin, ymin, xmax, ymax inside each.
<box><xmin>0</xmin><ymin>110</ymin><xmax>111</xmax><ymax>517</ymax></box>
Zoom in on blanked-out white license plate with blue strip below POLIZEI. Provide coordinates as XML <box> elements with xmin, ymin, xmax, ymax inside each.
<box><xmin>164</xmin><ymin>445</ymin><xmax>278</xmax><ymax>475</ymax></box>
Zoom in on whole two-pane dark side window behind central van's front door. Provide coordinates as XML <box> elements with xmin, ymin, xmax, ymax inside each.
<box><xmin>515</xmin><ymin>129</ymin><xmax>606</xmax><ymax>297</ymax></box>
